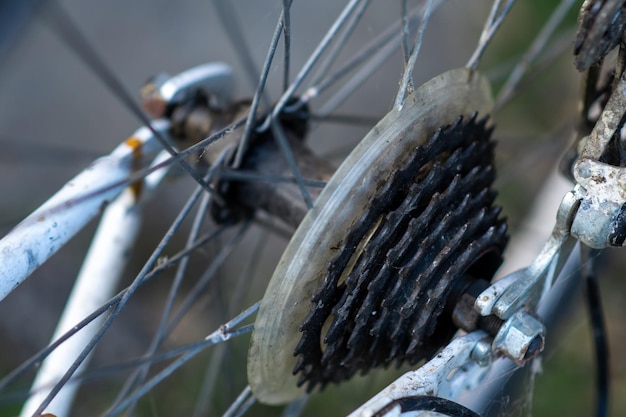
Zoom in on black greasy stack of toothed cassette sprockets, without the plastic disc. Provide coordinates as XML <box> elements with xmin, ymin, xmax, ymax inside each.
<box><xmin>294</xmin><ymin>114</ymin><xmax>507</xmax><ymax>390</ymax></box>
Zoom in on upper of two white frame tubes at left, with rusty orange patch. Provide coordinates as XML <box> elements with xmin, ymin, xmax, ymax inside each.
<box><xmin>0</xmin><ymin>121</ymin><xmax>168</xmax><ymax>298</ymax></box>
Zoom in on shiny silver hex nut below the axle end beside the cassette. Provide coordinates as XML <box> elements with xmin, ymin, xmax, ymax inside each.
<box><xmin>493</xmin><ymin>310</ymin><xmax>546</xmax><ymax>365</ymax></box>
